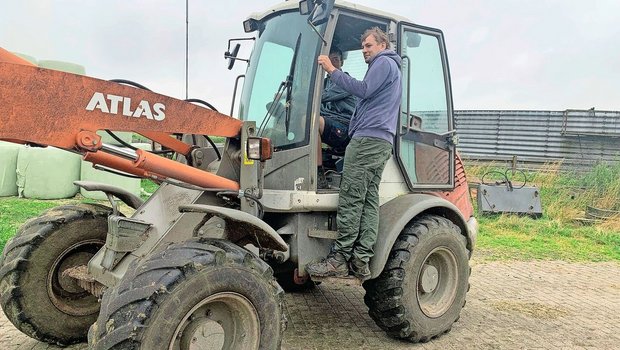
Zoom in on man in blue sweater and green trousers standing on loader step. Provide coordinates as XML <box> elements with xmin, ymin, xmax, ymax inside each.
<box><xmin>306</xmin><ymin>27</ymin><xmax>402</xmax><ymax>281</ymax></box>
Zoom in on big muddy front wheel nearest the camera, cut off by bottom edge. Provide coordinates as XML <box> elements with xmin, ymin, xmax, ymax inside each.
<box><xmin>89</xmin><ymin>239</ymin><xmax>285</xmax><ymax>350</ymax></box>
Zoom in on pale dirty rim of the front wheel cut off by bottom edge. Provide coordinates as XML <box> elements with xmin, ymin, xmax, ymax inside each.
<box><xmin>169</xmin><ymin>292</ymin><xmax>260</xmax><ymax>350</ymax></box>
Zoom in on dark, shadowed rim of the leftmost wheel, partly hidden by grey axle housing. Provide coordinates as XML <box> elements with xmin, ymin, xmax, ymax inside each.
<box><xmin>46</xmin><ymin>239</ymin><xmax>105</xmax><ymax>316</ymax></box>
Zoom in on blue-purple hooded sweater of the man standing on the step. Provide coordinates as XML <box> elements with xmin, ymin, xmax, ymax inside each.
<box><xmin>330</xmin><ymin>50</ymin><xmax>402</xmax><ymax>143</ymax></box>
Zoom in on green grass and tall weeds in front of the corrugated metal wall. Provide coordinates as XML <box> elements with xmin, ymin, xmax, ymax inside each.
<box><xmin>468</xmin><ymin>163</ymin><xmax>620</xmax><ymax>261</ymax></box>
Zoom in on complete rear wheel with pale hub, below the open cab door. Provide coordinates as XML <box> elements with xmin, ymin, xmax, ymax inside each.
<box><xmin>364</xmin><ymin>215</ymin><xmax>470</xmax><ymax>342</ymax></box>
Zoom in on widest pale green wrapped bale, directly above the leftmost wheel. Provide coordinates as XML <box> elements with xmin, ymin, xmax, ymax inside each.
<box><xmin>17</xmin><ymin>147</ymin><xmax>81</xmax><ymax>199</ymax></box>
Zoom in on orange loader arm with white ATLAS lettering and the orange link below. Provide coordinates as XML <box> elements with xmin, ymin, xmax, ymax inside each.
<box><xmin>0</xmin><ymin>48</ymin><xmax>242</xmax><ymax>190</ymax></box>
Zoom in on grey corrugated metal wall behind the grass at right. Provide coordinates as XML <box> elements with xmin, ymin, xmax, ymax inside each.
<box><xmin>455</xmin><ymin>110</ymin><xmax>620</xmax><ymax>169</ymax></box>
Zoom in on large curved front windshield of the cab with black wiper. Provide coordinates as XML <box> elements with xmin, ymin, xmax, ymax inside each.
<box><xmin>239</xmin><ymin>11</ymin><xmax>323</xmax><ymax>151</ymax></box>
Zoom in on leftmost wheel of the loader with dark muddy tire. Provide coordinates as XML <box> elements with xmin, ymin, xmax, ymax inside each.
<box><xmin>0</xmin><ymin>204</ymin><xmax>112</xmax><ymax>345</ymax></box>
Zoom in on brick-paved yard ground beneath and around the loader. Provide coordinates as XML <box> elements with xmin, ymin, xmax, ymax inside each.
<box><xmin>0</xmin><ymin>260</ymin><xmax>620</xmax><ymax>350</ymax></box>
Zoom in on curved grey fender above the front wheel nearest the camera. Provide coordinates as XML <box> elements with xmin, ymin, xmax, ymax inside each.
<box><xmin>179</xmin><ymin>204</ymin><xmax>288</xmax><ymax>252</ymax></box>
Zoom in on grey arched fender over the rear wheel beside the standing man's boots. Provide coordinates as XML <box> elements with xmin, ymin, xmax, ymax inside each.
<box><xmin>370</xmin><ymin>194</ymin><xmax>477</xmax><ymax>278</ymax></box>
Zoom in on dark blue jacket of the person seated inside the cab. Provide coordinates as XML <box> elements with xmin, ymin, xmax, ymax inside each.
<box><xmin>321</xmin><ymin>73</ymin><xmax>357</xmax><ymax>126</ymax></box>
